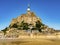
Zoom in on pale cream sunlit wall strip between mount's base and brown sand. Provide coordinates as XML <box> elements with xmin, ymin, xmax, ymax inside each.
<box><xmin>19</xmin><ymin>35</ymin><xmax>60</xmax><ymax>39</ymax></box>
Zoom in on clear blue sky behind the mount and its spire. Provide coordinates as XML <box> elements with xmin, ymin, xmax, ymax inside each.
<box><xmin>0</xmin><ymin>0</ymin><xmax>60</xmax><ymax>30</ymax></box>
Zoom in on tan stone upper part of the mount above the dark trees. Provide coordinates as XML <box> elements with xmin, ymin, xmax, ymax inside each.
<box><xmin>10</xmin><ymin>12</ymin><xmax>41</xmax><ymax>26</ymax></box>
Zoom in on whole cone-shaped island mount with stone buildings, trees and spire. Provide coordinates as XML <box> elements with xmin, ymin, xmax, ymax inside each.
<box><xmin>2</xmin><ymin>5</ymin><xmax>55</xmax><ymax>38</ymax></box>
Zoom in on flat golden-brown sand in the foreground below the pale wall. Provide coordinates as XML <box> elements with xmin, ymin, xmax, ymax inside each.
<box><xmin>0</xmin><ymin>39</ymin><xmax>60</xmax><ymax>45</ymax></box>
